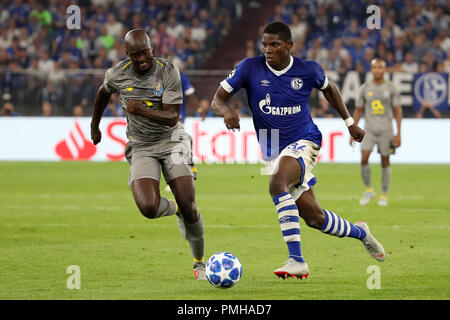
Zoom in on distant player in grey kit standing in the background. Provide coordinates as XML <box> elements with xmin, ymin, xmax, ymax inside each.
<box><xmin>350</xmin><ymin>59</ymin><xmax>402</xmax><ymax>206</ymax></box>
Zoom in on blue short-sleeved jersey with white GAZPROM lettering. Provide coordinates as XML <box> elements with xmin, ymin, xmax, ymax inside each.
<box><xmin>220</xmin><ymin>55</ymin><xmax>328</xmax><ymax>160</ymax></box>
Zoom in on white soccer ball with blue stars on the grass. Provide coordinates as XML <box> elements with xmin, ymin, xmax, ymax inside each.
<box><xmin>206</xmin><ymin>252</ymin><xmax>242</xmax><ymax>289</ymax></box>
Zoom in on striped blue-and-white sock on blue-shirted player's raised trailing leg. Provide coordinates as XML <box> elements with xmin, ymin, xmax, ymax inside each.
<box><xmin>320</xmin><ymin>210</ymin><xmax>366</xmax><ymax>240</ymax></box>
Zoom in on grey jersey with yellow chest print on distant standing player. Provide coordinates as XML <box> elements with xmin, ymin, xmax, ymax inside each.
<box><xmin>356</xmin><ymin>80</ymin><xmax>400</xmax><ymax>131</ymax></box>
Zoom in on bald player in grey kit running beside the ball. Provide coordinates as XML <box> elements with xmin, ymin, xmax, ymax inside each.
<box><xmin>91</xmin><ymin>29</ymin><xmax>206</xmax><ymax>280</ymax></box>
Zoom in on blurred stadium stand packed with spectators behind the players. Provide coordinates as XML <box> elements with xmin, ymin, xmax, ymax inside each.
<box><xmin>0</xmin><ymin>0</ymin><xmax>450</xmax><ymax>117</ymax></box>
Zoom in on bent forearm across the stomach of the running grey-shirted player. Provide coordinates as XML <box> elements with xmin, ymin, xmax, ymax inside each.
<box><xmin>126</xmin><ymin>100</ymin><xmax>181</xmax><ymax>127</ymax></box>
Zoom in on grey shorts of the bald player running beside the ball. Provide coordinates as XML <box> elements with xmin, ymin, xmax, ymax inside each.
<box><xmin>125</xmin><ymin>133</ymin><xmax>197</xmax><ymax>188</ymax></box>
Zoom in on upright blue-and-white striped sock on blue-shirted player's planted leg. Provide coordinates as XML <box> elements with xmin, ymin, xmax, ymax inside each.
<box><xmin>273</xmin><ymin>192</ymin><xmax>305</xmax><ymax>262</ymax></box>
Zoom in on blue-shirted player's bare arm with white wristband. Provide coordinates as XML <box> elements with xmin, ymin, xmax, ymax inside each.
<box><xmin>322</xmin><ymin>81</ymin><xmax>365</xmax><ymax>142</ymax></box>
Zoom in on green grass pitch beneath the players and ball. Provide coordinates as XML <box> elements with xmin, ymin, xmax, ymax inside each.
<box><xmin>0</xmin><ymin>162</ymin><xmax>450</xmax><ymax>300</ymax></box>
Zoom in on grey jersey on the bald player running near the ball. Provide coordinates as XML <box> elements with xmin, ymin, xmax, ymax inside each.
<box><xmin>103</xmin><ymin>58</ymin><xmax>183</xmax><ymax>145</ymax></box>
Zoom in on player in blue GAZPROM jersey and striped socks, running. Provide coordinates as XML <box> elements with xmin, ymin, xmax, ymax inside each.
<box><xmin>211</xmin><ymin>22</ymin><xmax>385</xmax><ymax>279</ymax></box>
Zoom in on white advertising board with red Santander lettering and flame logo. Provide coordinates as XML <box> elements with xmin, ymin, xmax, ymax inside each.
<box><xmin>0</xmin><ymin>117</ymin><xmax>450</xmax><ymax>163</ymax></box>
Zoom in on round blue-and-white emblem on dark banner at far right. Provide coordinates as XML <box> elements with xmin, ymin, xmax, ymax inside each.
<box><xmin>414</xmin><ymin>72</ymin><xmax>447</xmax><ymax>106</ymax></box>
